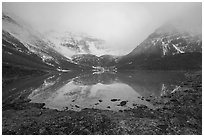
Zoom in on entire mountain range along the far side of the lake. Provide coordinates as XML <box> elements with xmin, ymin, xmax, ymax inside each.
<box><xmin>2</xmin><ymin>12</ymin><xmax>202</xmax><ymax>75</ymax></box>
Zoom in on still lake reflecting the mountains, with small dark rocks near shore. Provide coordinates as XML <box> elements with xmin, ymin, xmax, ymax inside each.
<box><xmin>3</xmin><ymin>71</ymin><xmax>186</xmax><ymax>111</ymax></box>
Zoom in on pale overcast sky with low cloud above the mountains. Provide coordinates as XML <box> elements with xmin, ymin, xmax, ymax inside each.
<box><xmin>3</xmin><ymin>3</ymin><xmax>202</xmax><ymax>53</ymax></box>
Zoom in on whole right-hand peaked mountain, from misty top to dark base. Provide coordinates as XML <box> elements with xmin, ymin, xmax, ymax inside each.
<box><xmin>116</xmin><ymin>24</ymin><xmax>202</xmax><ymax>70</ymax></box>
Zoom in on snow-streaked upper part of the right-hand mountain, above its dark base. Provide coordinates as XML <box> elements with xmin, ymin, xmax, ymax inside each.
<box><xmin>130</xmin><ymin>24</ymin><xmax>202</xmax><ymax>56</ymax></box>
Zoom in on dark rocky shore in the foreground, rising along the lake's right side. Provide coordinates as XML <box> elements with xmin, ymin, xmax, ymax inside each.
<box><xmin>2</xmin><ymin>71</ymin><xmax>202</xmax><ymax>135</ymax></box>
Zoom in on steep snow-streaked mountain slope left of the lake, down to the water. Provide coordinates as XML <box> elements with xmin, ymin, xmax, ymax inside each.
<box><xmin>2</xmin><ymin>13</ymin><xmax>80</xmax><ymax>78</ymax></box>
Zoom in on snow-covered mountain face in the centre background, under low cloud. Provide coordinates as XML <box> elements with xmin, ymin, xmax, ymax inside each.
<box><xmin>44</xmin><ymin>31</ymin><xmax>107</xmax><ymax>58</ymax></box>
